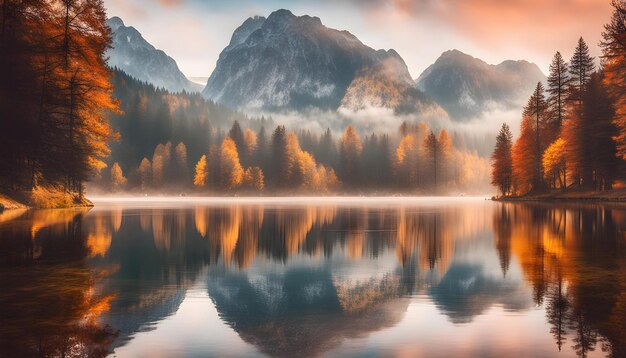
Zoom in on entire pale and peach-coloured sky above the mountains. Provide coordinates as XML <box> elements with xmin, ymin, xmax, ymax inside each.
<box><xmin>104</xmin><ymin>0</ymin><xmax>611</xmax><ymax>78</ymax></box>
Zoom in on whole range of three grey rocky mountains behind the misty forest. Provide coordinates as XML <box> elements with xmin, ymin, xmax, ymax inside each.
<box><xmin>108</xmin><ymin>10</ymin><xmax>545</xmax><ymax>121</ymax></box>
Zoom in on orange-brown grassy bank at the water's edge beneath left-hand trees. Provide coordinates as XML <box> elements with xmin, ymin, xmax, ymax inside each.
<box><xmin>0</xmin><ymin>187</ymin><xmax>93</xmax><ymax>211</ymax></box>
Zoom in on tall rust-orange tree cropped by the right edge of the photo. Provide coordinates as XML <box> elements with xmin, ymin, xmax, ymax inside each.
<box><xmin>600</xmin><ymin>0</ymin><xmax>626</xmax><ymax>159</ymax></box>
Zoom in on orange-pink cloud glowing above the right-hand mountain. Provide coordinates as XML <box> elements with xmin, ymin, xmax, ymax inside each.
<box><xmin>360</xmin><ymin>0</ymin><xmax>611</xmax><ymax>58</ymax></box>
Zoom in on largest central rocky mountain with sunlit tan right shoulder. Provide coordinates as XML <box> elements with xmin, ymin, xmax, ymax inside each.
<box><xmin>202</xmin><ymin>10</ymin><xmax>436</xmax><ymax>114</ymax></box>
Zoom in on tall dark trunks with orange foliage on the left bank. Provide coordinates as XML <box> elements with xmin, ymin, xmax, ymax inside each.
<box><xmin>0</xmin><ymin>0</ymin><xmax>119</xmax><ymax>197</ymax></box>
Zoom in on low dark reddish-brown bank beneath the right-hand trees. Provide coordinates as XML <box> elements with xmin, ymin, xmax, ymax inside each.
<box><xmin>492</xmin><ymin>188</ymin><xmax>626</xmax><ymax>202</ymax></box>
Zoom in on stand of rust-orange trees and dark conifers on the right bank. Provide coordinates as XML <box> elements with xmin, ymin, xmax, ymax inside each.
<box><xmin>491</xmin><ymin>1</ymin><xmax>626</xmax><ymax>196</ymax></box>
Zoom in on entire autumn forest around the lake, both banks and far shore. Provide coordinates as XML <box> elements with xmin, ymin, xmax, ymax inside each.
<box><xmin>7</xmin><ymin>0</ymin><xmax>626</xmax><ymax>199</ymax></box>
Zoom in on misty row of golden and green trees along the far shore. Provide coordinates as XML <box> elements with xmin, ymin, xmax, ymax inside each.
<box><xmin>99</xmin><ymin>121</ymin><xmax>488</xmax><ymax>193</ymax></box>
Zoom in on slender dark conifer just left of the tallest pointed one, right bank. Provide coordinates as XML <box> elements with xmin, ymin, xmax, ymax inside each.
<box><xmin>546</xmin><ymin>51</ymin><xmax>569</xmax><ymax>143</ymax></box>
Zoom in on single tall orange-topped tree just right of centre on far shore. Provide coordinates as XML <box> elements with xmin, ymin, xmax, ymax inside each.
<box><xmin>339</xmin><ymin>125</ymin><xmax>363</xmax><ymax>189</ymax></box>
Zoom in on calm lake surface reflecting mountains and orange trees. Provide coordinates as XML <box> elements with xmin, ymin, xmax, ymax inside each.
<box><xmin>0</xmin><ymin>198</ymin><xmax>626</xmax><ymax>357</ymax></box>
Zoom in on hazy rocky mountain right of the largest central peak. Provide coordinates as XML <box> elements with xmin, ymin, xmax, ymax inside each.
<box><xmin>416</xmin><ymin>50</ymin><xmax>546</xmax><ymax>121</ymax></box>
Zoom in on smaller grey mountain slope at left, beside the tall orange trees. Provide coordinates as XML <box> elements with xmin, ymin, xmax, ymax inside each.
<box><xmin>106</xmin><ymin>17</ymin><xmax>202</xmax><ymax>92</ymax></box>
